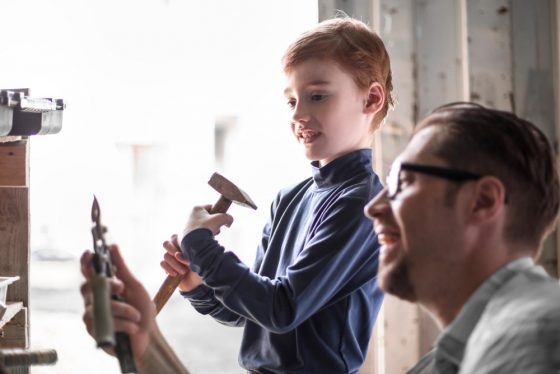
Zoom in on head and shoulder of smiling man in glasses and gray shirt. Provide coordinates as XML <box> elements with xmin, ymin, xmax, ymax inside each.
<box><xmin>364</xmin><ymin>103</ymin><xmax>560</xmax><ymax>374</ymax></box>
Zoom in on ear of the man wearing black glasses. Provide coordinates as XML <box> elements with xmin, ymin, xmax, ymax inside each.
<box><xmin>471</xmin><ymin>176</ymin><xmax>506</xmax><ymax>222</ymax></box>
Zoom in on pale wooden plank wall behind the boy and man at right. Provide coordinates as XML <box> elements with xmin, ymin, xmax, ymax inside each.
<box><xmin>318</xmin><ymin>0</ymin><xmax>560</xmax><ymax>374</ymax></box>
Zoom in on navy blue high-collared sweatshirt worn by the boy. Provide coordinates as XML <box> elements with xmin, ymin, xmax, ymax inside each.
<box><xmin>181</xmin><ymin>149</ymin><xmax>383</xmax><ymax>374</ymax></box>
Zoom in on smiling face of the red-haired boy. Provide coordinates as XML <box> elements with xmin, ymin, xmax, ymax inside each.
<box><xmin>284</xmin><ymin>59</ymin><xmax>373</xmax><ymax>166</ymax></box>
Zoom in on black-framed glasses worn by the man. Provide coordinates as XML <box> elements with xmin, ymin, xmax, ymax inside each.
<box><xmin>387</xmin><ymin>162</ymin><xmax>482</xmax><ymax>200</ymax></box>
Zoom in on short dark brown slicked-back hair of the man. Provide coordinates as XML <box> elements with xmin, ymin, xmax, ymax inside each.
<box><xmin>414</xmin><ymin>103</ymin><xmax>560</xmax><ymax>245</ymax></box>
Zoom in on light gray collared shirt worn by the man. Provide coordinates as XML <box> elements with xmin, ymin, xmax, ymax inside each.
<box><xmin>408</xmin><ymin>257</ymin><xmax>560</xmax><ymax>374</ymax></box>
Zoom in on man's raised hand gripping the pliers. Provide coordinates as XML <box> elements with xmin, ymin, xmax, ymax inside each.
<box><xmin>80</xmin><ymin>245</ymin><xmax>156</xmax><ymax>361</ymax></box>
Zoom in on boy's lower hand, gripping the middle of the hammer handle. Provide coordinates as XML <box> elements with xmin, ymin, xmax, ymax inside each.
<box><xmin>160</xmin><ymin>235</ymin><xmax>202</xmax><ymax>292</ymax></box>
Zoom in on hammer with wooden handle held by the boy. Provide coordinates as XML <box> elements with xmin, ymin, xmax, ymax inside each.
<box><xmin>154</xmin><ymin>173</ymin><xmax>257</xmax><ymax>314</ymax></box>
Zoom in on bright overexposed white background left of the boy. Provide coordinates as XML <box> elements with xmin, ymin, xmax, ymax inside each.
<box><xmin>0</xmin><ymin>0</ymin><xmax>317</xmax><ymax>373</ymax></box>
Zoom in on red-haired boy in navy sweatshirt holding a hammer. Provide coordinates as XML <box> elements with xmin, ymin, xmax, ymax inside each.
<box><xmin>81</xmin><ymin>18</ymin><xmax>392</xmax><ymax>374</ymax></box>
